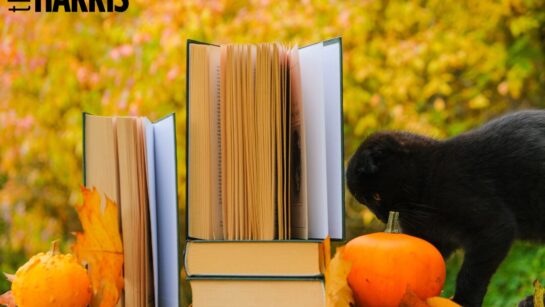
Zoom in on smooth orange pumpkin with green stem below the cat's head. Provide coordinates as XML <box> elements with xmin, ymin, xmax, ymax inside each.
<box><xmin>344</xmin><ymin>212</ymin><xmax>446</xmax><ymax>307</ymax></box>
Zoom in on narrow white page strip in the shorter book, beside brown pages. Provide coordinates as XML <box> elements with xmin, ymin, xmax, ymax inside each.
<box><xmin>142</xmin><ymin>117</ymin><xmax>159</xmax><ymax>306</ymax></box>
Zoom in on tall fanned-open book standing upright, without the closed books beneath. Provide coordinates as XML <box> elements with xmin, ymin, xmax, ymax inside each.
<box><xmin>186</xmin><ymin>38</ymin><xmax>344</xmax><ymax>240</ymax></box>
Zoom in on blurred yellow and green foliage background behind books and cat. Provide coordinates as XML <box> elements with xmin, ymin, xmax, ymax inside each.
<box><xmin>0</xmin><ymin>0</ymin><xmax>545</xmax><ymax>306</ymax></box>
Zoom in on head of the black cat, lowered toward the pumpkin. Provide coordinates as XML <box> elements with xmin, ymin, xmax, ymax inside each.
<box><xmin>346</xmin><ymin>132</ymin><xmax>432</xmax><ymax>222</ymax></box>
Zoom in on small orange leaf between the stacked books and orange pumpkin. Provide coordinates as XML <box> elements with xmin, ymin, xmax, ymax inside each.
<box><xmin>325</xmin><ymin>246</ymin><xmax>355</xmax><ymax>307</ymax></box>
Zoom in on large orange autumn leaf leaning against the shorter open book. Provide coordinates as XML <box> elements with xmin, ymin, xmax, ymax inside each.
<box><xmin>72</xmin><ymin>187</ymin><xmax>123</xmax><ymax>307</ymax></box>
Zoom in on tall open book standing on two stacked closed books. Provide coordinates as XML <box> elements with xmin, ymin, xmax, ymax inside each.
<box><xmin>185</xmin><ymin>38</ymin><xmax>344</xmax><ymax>307</ymax></box>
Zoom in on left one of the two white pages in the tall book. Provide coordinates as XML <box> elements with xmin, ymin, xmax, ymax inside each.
<box><xmin>299</xmin><ymin>43</ymin><xmax>328</xmax><ymax>239</ymax></box>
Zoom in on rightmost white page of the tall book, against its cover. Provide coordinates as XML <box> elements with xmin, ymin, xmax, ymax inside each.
<box><xmin>323</xmin><ymin>41</ymin><xmax>344</xmax><ymax>239</ymax></box>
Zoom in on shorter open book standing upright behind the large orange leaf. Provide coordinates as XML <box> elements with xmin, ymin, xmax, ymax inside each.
<box><xmin>83</xmin><ymin>114</ymin><xmax>180</xmax><ymax>306</ymax></box>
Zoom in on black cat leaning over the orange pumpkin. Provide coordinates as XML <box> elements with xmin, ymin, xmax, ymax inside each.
<box><xmin>346</xmin><ymin>110</ymin><xmax>545</xmax><ymax>307</ymax></box>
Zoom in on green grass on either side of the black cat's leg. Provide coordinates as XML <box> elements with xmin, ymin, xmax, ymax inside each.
<box><xmin>442</xmin><ymin>242</ymin><xmax>545</xmax><ymax>307</ymax></box>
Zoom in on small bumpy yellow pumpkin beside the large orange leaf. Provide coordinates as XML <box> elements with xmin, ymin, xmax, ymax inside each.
<box><xmin>11</xmin><ymin>241</ymin><xmax>91</xmax><ymax>307</ymax></box>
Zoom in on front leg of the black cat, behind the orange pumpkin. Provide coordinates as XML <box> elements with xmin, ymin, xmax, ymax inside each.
<box><xmin>453</xmin><ymin>215</ymin><xmax>516</xmax><ymax>307</ymax></box>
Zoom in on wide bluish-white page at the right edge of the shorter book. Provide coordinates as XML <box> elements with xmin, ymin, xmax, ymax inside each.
<box><xmin>153</xmin><ymin>115</ymin><xmax>180</xmax><ymax>306</ymax></box>
